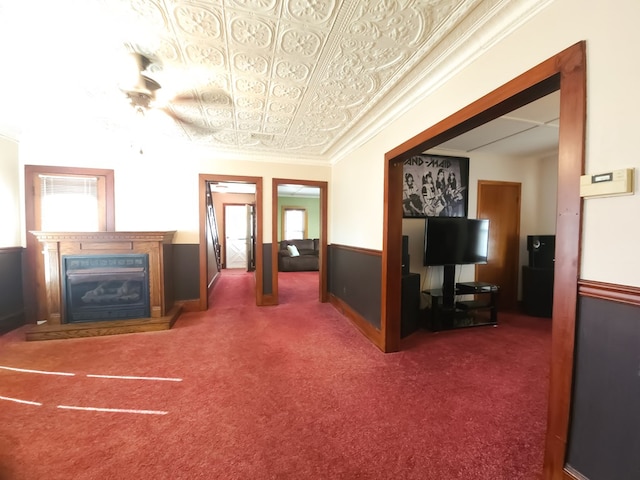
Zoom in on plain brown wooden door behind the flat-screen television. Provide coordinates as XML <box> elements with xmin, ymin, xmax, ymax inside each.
<box><xmin>476</xmin><ymin>180</ymin><xmax>522</xmax><ymax>311</ymax></box>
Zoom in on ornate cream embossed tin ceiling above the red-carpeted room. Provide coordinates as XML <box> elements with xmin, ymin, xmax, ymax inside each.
<box><xmin>2</xmin><ymin>0</ymin><xmax>546</xmax><ymax>158</ymax></box>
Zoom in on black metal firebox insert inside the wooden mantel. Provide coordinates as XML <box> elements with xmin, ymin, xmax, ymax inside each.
<box><xmin>62</xmin><ymin>254</ymin><xmax>150</xmax><ymax>323</ymax></box>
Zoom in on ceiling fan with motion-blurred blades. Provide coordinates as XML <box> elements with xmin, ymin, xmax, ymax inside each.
<box><xmin>120</xmin><ymin>50</ymin><xmax>229</xmax><ymax>133</ymax></box>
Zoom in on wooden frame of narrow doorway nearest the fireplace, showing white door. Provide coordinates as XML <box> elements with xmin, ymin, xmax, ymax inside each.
<box><xmin>198</xmin><ymin>173</ymin><xmax>264</xmax><ymax>310</ymax></box>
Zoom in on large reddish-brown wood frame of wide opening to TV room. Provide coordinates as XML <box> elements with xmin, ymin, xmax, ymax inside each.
<box><xmin>380</xmin><ymin>41</ymin><xmax>586</xmax><ymax>480</ymax></box>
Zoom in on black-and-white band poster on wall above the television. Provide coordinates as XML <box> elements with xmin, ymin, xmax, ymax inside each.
<box><xmin>402</xmin><ymin>154</ymin><xmax>469</xmax><ymax>218</ymax></box>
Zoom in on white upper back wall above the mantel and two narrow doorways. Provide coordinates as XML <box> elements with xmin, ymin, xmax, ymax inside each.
<box><xmin>20</xmin><ymin>127</ymin><xmax>330</xmax><ymax>243</ymax></box>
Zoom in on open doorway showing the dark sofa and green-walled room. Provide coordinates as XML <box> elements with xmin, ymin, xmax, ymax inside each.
<box><xmin>272</xmin><ymin>178</ymin><xmax>328</xmax><ymax>304</ymax></box>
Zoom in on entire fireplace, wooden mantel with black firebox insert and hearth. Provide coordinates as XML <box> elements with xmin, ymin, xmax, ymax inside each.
<box><xmin>27</xmin><ymin>231</ymin><xmax>182</xmax><ymax>340</ymax></box>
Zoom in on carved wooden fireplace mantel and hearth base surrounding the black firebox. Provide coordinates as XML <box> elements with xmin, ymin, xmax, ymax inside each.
<box><xmin>27</xmin><ymin>231</ymin><xmax>180</xmax><ymax>340</ymax></box>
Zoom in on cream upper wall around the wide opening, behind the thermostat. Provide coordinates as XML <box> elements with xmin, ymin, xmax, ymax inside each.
<box><xmin>330</xmin><ymin>0</ymin><xmax>640</xmax><ymax>286</ymax></box>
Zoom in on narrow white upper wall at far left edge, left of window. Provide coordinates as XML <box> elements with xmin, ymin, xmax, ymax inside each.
<box><xmin>0</xmin><ymin>136</ymin><xmax>22</xmax><ymax>248</ymax></box>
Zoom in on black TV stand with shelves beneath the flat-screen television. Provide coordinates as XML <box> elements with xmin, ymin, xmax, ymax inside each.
<box><xmin>423</xmin><ymin>282</ymin><xmax>500</xmax><ymax>332</ymax></box>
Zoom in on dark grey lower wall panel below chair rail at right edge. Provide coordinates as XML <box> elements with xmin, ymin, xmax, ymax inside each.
<box><xmin>567</xmin><ymin>296</ymin><xmax>640</xmax><ymax>480</ymax></box>
